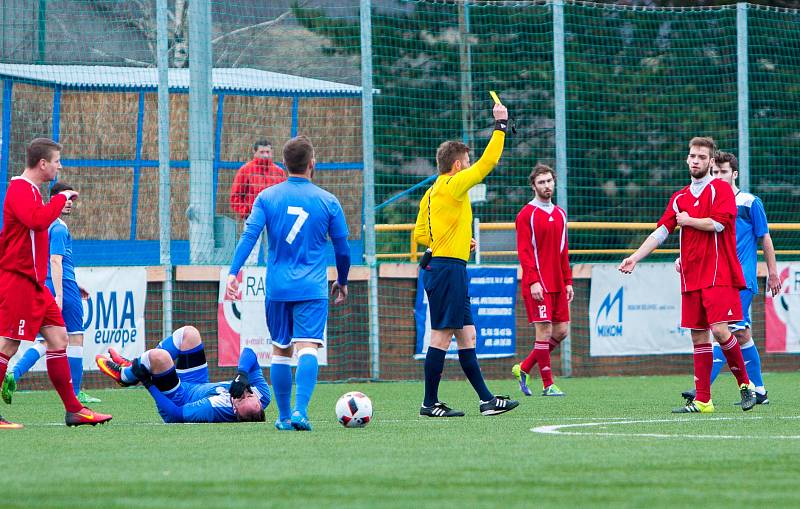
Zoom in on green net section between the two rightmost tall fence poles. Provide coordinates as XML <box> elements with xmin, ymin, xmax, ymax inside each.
<box><xmin>565</xmin><ymin>5</ymin><xmax>737</xmax><ymax>256</ymax></box>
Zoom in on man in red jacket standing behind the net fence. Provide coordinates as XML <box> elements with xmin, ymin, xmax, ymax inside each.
<box><xmin>231</xmin><ymin>138</ymin><xmax>286</xmax><ymax>265</ymax></box>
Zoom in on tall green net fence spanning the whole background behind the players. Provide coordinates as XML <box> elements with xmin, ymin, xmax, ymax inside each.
<box><xmin>0</xmin><ymin>0</ymin><xmax>800</xmax><ymax>384</ymax></box>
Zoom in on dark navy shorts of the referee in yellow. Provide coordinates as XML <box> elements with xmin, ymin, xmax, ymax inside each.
<box><xmin>422</xmin><ymin>256</ymin><xmax>475</xmax><ymax>330</ymax></box>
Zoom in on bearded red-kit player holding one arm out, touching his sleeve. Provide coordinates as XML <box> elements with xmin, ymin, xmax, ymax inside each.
<box><xmin>619</xmin><ymin>137</ymin><xmax>756</xmax><ymax>413</ymax></box>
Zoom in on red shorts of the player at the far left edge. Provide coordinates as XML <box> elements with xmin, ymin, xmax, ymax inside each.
<box><xmin>0</xmin><ymin>271</ymin><xmax>66</xmax><ymax>341</ymax></box>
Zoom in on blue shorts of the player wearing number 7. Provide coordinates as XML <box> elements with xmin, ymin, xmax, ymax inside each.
<box><xmin>266</xmin><ymin>299</ymin><xmax>328</xmax><ymax>348</ymax></box>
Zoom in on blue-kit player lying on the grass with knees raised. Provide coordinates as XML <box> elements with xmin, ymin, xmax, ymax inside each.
<box><xmin>96</xmin><ymin>325</ymin><xmax>270</xmax><ymax>424</ymax></box>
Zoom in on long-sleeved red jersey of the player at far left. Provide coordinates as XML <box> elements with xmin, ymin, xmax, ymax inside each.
<box><xmin>0</xmin><ymin>177</ymin><xmax>67</xmax><ymax>285</ymax></box>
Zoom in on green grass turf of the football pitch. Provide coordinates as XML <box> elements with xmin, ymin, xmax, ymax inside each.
<box><xmin>0</xmin><ymin>373</ymin><xmax>800</xmax><ymax>509</ymax></box>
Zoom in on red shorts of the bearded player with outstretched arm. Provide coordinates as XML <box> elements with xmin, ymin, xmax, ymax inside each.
<box><xmin>681</xmin><ymin>286</ymin><xmax>742</xmax><ymax>330</ymax></box>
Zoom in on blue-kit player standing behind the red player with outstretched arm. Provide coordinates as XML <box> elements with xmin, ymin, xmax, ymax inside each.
<box><xmin>683</xmin><ymin>152</ymin><xmax>781</xmax><ymax>405</ymax></box>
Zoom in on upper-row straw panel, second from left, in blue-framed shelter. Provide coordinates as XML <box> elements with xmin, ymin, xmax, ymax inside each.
<box><xmin>59</xmin><ymin>90</ymin><xmax>139</xmax><ymax>160</ymax></box>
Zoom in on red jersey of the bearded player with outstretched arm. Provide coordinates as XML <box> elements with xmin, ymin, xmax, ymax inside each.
<box><xmin>658</xmin><ymin>175</ymin><xmax>745</xmax><ymax>293</ymax></box>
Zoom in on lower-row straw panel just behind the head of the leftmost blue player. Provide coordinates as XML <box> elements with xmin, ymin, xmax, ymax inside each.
<box><xmin>59</xmin><ymin>167</ymin><xmax>133</xmax><ymax>240</ymax></box>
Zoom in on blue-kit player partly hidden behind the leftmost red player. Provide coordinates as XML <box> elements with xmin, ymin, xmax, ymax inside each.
<box><xmin>0</xmin><ymin>182</ymin><xmax>100</xmax><ymax>404</ymax></box>
